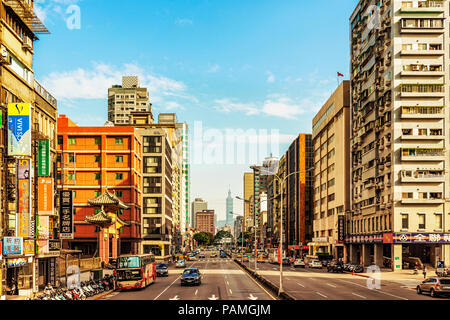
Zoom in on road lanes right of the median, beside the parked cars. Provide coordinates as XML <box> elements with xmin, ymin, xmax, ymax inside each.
<box><xmin>241</xmin><ymin>259</ymin><xmax>442</xmax><ymax>300</ymax></box>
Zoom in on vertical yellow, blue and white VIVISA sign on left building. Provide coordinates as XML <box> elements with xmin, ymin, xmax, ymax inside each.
<box><xmin>8</xmin><ymin>103</ymin><xmax>31</xmax><ymax>157</ymax></box>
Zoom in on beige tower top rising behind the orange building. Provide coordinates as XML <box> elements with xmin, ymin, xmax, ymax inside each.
<box><xmin>108</xmin><ymin>76</ymin><xmax>153</xmax><ymax>125</ymax></box>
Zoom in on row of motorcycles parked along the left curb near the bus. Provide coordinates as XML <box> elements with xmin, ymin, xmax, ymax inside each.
<box><xmin>33</xmin><ymin>275</ymin><xmax>114</xmax><ymax>300</ymax></box>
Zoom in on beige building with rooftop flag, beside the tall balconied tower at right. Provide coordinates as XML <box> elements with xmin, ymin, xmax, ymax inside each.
<box><xmin>308</xmin><ymin>81</ymin><xmax>350</xmax><ymax>259</ymax></box>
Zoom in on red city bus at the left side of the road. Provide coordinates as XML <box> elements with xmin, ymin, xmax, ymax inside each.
<box><xmin>114</xmin><ymin>253</ymin><xmax>156</xmax><ymax>290</ymax></box>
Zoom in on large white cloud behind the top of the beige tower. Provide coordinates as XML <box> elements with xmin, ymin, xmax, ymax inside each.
<box><xmin>41</xmin><ymin>63</ymin><xmax>198</xmax><ymax>105</ymax></box>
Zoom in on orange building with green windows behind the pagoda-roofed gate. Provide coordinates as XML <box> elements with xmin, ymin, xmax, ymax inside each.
<box><xmin>57</xmin><ymin>115</ymin><xmax>142</xmax><ymax>256</ymax></box>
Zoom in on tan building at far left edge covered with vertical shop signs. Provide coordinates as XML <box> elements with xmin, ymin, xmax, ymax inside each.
<box><xmin>0</xmin><ymin>0</ymin><xmax>59</xmax><ymax>297</ymax></box>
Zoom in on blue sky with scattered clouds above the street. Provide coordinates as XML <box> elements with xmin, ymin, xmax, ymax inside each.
<box><xmin>34</xmin><ymin>0</ymin><xmax>357</xmax><ymax>220</ymax></box>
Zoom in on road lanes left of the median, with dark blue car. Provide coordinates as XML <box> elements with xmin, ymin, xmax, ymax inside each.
<box><xmin>102</xmin><ymin>252</ymin><xmax>275</xmax><ymax>300</ymax></box>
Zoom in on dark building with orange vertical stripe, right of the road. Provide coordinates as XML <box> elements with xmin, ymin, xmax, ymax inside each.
<box><xmin>284</xmin><ymin>133</ymin><xmax>313</xmax><ymax>255</ymax></box>
